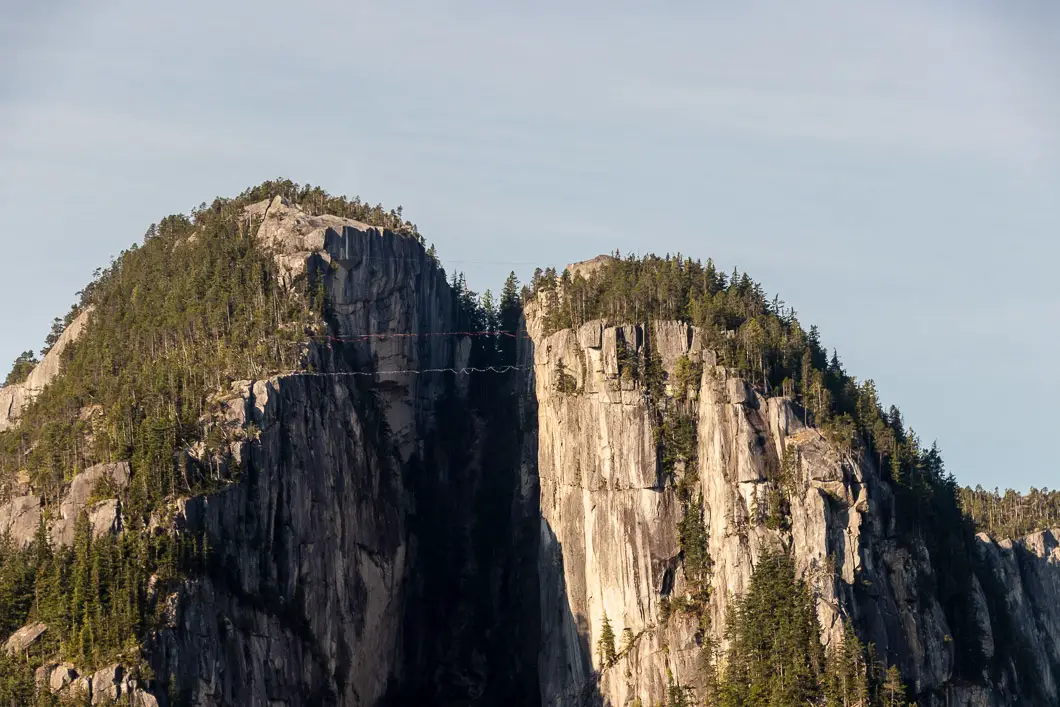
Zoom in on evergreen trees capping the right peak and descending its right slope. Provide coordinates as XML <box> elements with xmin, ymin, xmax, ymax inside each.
<box><xmin>527</xmin><ymin>252</ymin><xmax>985</xmax><ymax>679</ymax></box>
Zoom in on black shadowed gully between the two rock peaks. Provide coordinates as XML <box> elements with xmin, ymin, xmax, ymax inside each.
<box><xmin>385</xmin><ymin>324</ymin><xmax>603</xmax><ymax>707</ymax></box>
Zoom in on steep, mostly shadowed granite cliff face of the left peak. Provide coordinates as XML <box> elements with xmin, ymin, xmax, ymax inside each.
<box><xmin>138</xmin><ymin>198</ymin><xmax>536</xmax><ymax>705</ymax></box>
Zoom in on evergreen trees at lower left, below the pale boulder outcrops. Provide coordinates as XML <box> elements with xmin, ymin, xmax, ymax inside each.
<box><xmin>0</xmin><ymin>511</ymin><xmax>204</xmax><ymax>705</ymax></box>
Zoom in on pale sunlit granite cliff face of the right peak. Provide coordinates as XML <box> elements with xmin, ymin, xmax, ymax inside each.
<box><xmin>527</xmin><ymin>296</ymin><xmax>1060</xmax><ymax>705</ymax></box>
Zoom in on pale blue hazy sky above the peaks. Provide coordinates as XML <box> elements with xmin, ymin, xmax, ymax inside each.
<box><xmin>0</xmin><ymin>0</ymin><xmax>1060</xmax><ymax>489</ymax></box>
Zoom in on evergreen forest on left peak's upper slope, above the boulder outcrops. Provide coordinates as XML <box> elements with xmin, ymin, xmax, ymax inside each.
<box><xmin>0</xmin><ymin>199</ymin><xmax>316</xmax><ymax>510</ymax></box>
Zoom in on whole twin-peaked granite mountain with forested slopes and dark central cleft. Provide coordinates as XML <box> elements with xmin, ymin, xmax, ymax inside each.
<box><xmin>0</xmin><ymin>181</ymin><xmax>1060</xmax><ymax>706</ymax></box>
